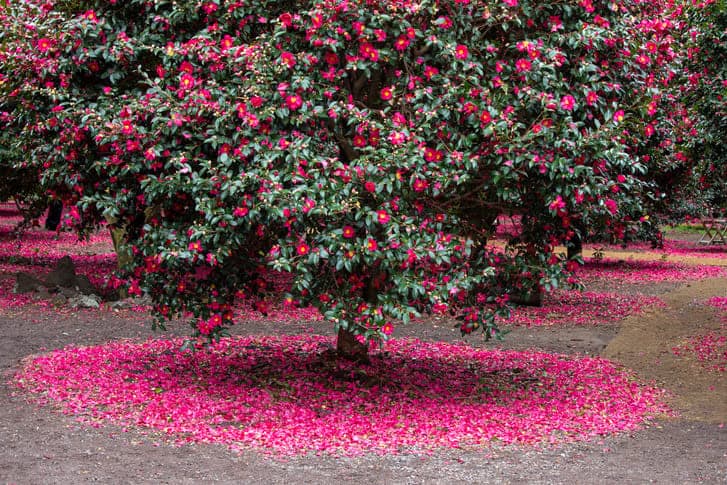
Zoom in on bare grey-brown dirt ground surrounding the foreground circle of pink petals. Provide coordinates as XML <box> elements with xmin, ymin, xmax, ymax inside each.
<box><xmin>0</xmin><ymin>242</ymin><xmax>727</xmax><ymax>484</ymax></box>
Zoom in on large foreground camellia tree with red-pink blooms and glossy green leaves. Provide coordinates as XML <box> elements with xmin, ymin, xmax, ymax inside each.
<box><xmin>0</xmin><ymin>0</ymin><xmax>680</xmax><ymax>356</ymax></box>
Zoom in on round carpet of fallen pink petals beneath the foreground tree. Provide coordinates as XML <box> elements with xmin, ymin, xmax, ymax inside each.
<box><xmin>14</xmin><ymin>336</ymin><xmax>668</xmax><ymax>455</ymax></box>
